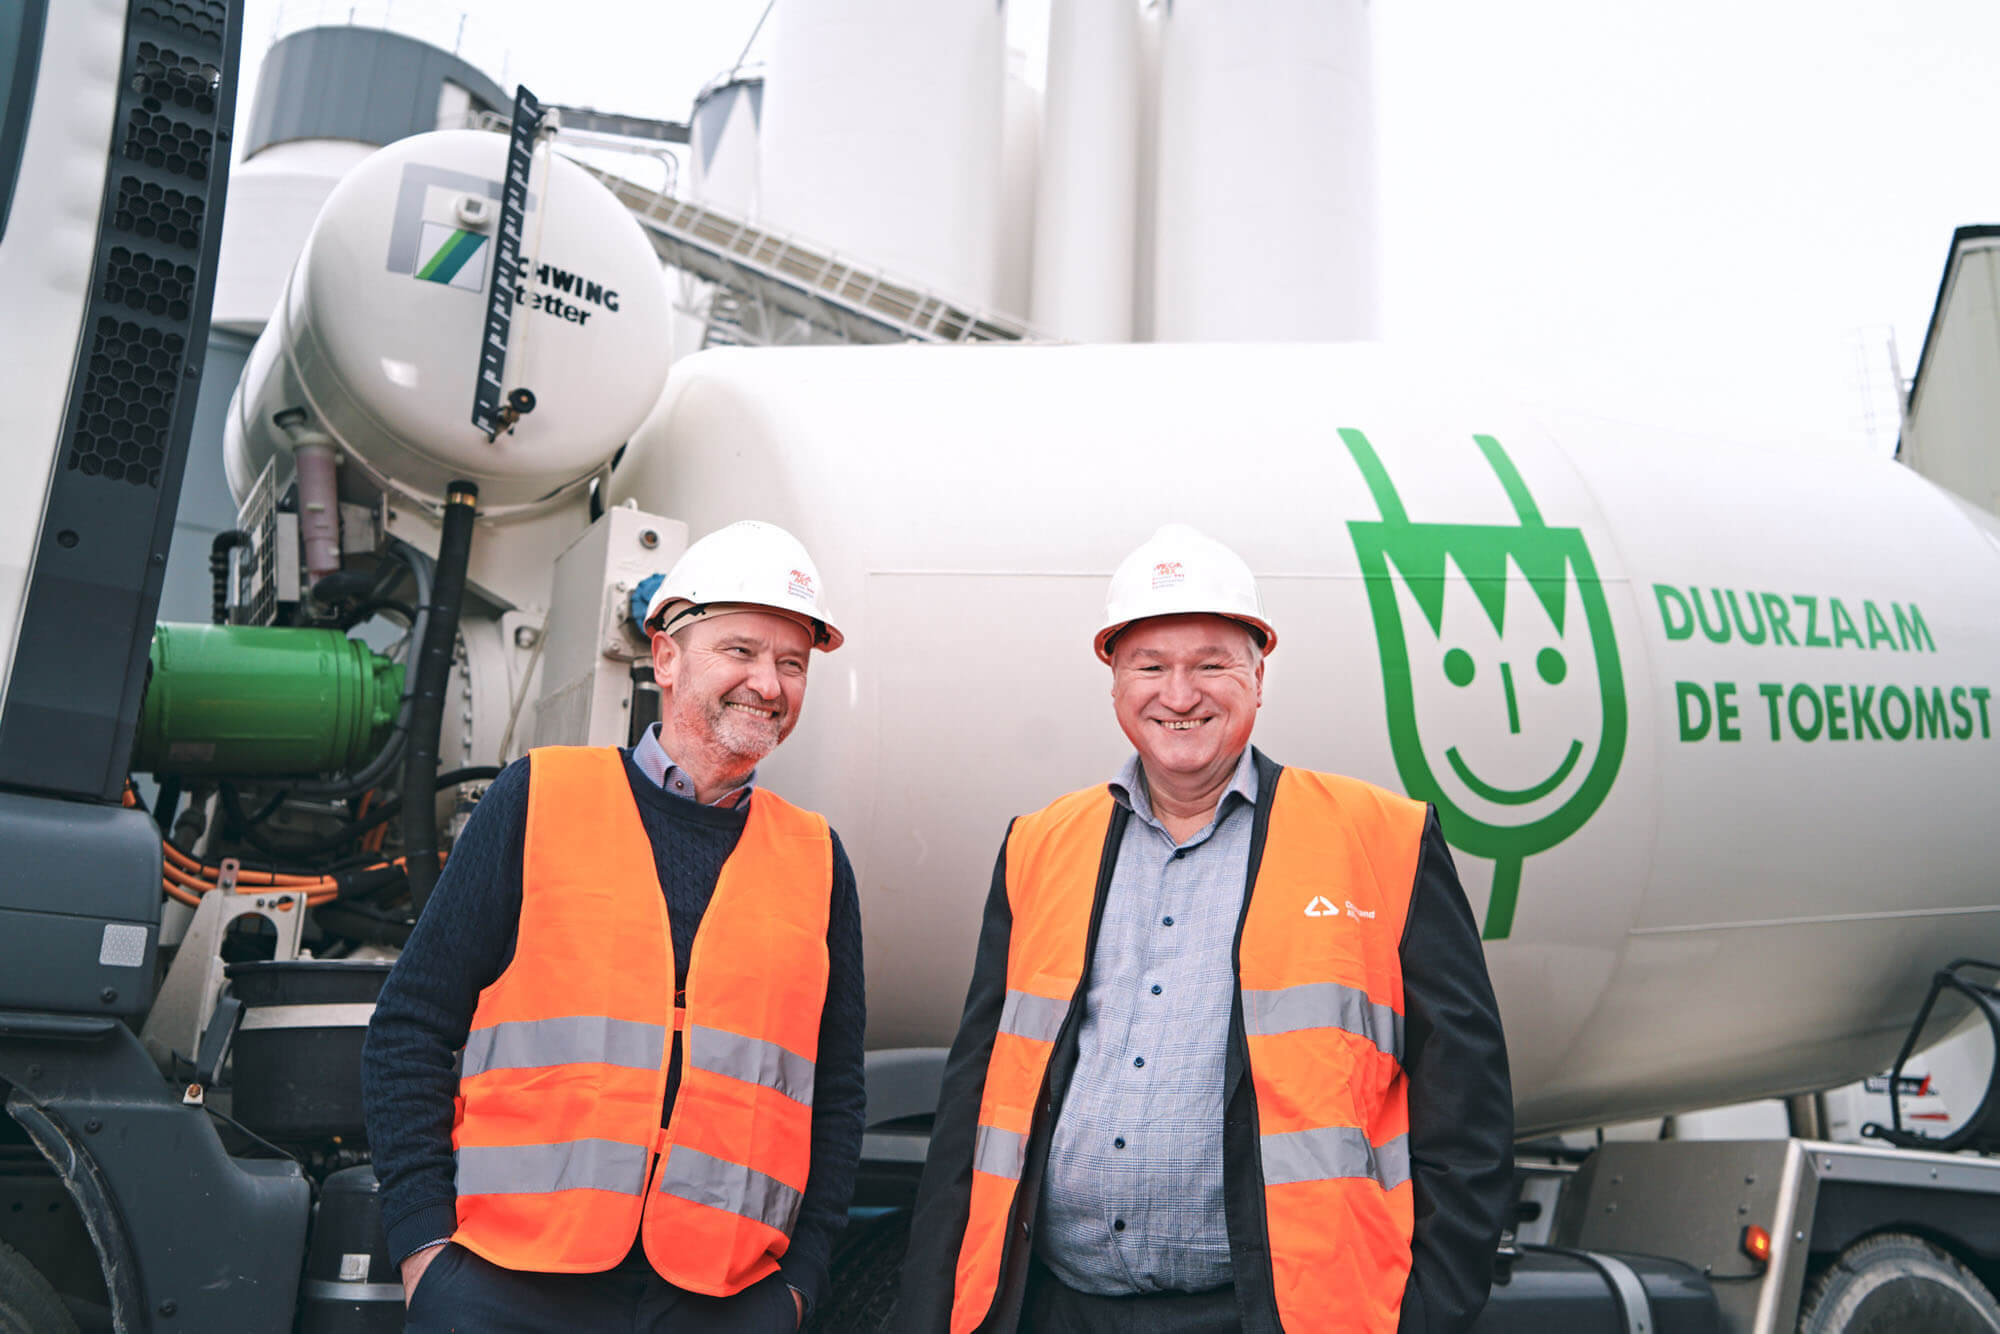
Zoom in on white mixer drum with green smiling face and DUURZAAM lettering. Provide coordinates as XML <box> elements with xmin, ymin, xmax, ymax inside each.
<box><xmin>614</xmin><ymin>346</ymin><xmax>2000</xmax><ymax>1130</ymax></box>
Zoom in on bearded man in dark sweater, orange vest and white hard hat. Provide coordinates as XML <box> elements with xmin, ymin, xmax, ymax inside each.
<box><xmin>362</xmin><ymin>522</ymin><xmax>864</xmax><ymax>1334</ymax></box>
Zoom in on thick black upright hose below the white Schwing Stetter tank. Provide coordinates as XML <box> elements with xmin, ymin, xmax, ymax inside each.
<box><xmin>402</xmin><ymin>482</ymin><xmax>480</xmax><ymax>912</ymax></box>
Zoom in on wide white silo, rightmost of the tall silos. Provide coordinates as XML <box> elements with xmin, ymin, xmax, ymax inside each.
<box><xmin>1152</xmin><ymin>0</ymin><xmax>1378</xmax><ymax>342</ymax></box>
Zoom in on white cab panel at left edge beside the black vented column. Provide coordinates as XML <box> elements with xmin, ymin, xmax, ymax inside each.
<box><xmin>0</xmin><ymin>0</ymin><xmax>126</xmax><ymax>720</ymax></box>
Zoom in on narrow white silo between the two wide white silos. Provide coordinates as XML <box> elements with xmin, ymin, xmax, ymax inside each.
<box><xmin>1030</xmin><ymin>0</ymin><xmax>1140</xmax><ymax>342</ymax></box>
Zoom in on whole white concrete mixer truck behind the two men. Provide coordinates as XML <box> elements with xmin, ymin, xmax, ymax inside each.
<box><xmin>0</xmin><ymin>0</ymin><xmax>2000</xmax><ymax>1332</ymax></box>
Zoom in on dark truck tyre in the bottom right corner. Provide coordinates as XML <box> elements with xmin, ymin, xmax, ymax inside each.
<box><xmin>1798</xmin><ymin>1232</ymin><xmax>2000</xmax><ymax>1334</ymax></box>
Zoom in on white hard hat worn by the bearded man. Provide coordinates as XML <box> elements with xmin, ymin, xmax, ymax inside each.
<box><xmin>646</xmin><ymin>518</ymin><xmax>842</xmax><ymax>652</ymax></box>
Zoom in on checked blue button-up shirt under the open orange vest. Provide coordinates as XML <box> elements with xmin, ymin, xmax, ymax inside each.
<box><xmin>1036</xmin><ymin>748</ymin><xmax>1258</xmax><ymax>1296</ymax></box>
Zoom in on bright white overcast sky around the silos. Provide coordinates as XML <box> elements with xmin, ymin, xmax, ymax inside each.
<box><xmin>244</xmin><ymin>0</ymin><xmax>2000</xmax><ymax>450</ymax></box>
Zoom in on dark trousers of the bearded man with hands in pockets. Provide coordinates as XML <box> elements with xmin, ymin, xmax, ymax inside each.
<box><xmin>402</xmin><ymin>1242</ymin><xmax>798</xmax><ymax>1334</ymax></box>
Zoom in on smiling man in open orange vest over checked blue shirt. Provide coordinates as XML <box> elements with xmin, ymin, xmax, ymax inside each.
<box><xmin>900</xmin><ymin>526</ymin><xmax>1514</xmax><ymax>1334</ymax></box>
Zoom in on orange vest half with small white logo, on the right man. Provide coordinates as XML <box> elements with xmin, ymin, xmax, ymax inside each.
<box><xmin>1236</xmin><ymin>768</ymin><xmax>1424</xmax><ymax>1334</ymax></box>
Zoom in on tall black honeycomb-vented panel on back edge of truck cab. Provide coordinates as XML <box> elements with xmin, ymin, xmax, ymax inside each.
<box><xmin>0</xmin><ymin>0</ymin><xmax>242</xmax><ymax>800</ymax></box>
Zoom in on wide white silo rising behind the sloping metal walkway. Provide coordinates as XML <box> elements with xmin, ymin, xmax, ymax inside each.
<box><xmin>762</xmin><ymin>0</ymin><xmax>1006</xmax><ymax>306</ymax></box>
